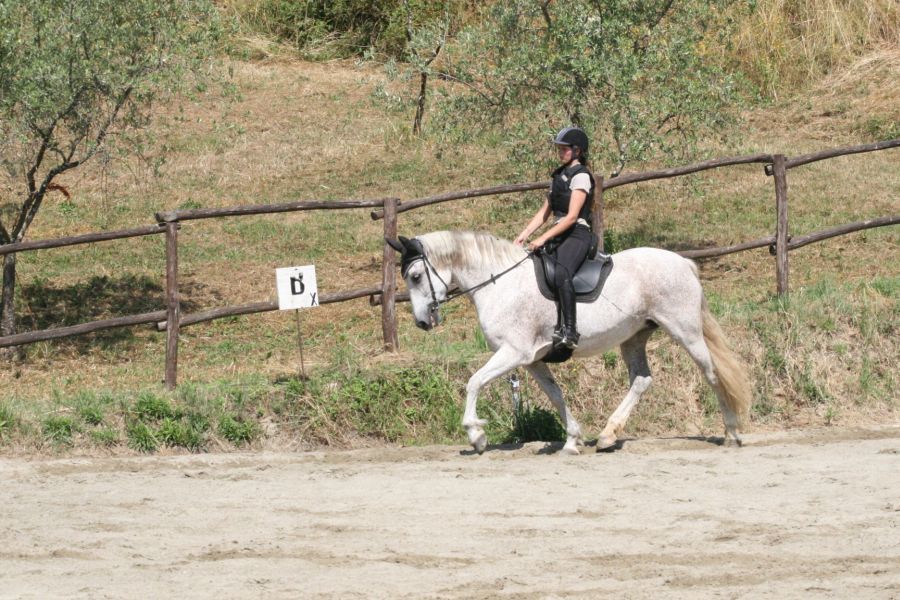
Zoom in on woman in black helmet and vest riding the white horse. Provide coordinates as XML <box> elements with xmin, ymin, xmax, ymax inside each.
<box><xmin>515</xmin><ymin>127</ymin><xmax>594</xmax><ymax>349</ymax></box>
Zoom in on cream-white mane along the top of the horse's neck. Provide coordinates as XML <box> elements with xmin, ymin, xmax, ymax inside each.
<box><xmin>417</xmin><ymin>231</ymin><xmax>525</xmax><ymax>270</ymax></box>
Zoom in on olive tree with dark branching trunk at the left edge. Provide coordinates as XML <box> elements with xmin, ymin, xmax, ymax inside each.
<box><xmin>0</xmin><ymin>0</ymin><xmax>222</xmax><ymax>344</ymax></box>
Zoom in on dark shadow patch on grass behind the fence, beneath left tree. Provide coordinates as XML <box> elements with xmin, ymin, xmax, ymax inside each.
<box><xmin>16</xmin><ymin>274</ymin><xmax>193</xmax><ymax>354</ymax></box>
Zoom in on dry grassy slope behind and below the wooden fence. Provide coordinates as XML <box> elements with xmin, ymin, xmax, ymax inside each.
<box><xmin>0</xmin><ymin>51</ymin><xmax>900</xmax><ymax>451</ymax></box>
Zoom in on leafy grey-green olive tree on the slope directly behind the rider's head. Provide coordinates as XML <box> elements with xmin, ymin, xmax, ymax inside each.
<box><xmin>428</xmin><ymin>0</ymin><xmax>746</xmax><ymax>175</ymax></box>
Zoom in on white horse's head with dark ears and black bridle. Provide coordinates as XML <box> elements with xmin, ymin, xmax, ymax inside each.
<box><xmin>384</xmin><ymin>235</ymin><xmax>450</xmax><ymax>331</ymax></box>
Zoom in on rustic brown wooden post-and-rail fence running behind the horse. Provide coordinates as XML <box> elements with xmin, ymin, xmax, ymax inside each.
<box><xmin>0</xmin><ymin>140</ymin><xmax>900</xmax><ymax>389</ymax></box>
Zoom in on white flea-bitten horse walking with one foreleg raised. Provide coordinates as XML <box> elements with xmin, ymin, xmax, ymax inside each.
<box><xmin>387</xmin><ymin>231</ymin><xmax>751</xmax><ymax>454</ymax></box>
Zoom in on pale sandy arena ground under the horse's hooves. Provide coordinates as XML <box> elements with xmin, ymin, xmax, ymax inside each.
<box><xmin>0</xmin><ymin>427</ymin><xmax>900</xmax><ymax>599</ymax></box>
